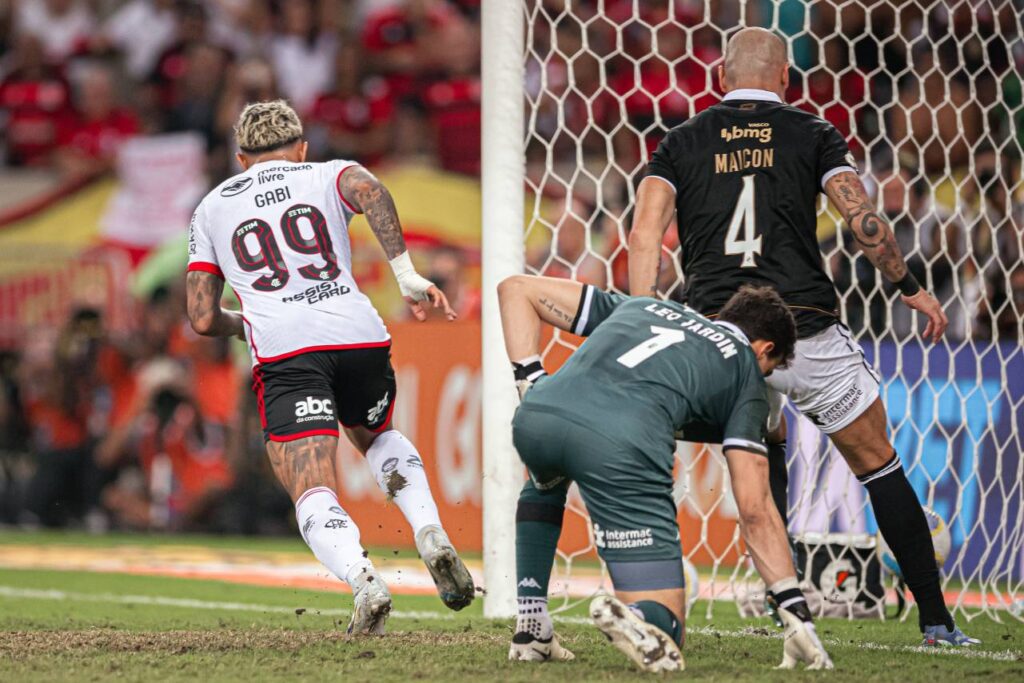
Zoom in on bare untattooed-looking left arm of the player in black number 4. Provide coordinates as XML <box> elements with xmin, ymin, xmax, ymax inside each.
<box><xmin>629</xmin><ymin>178</ymin><xmax>676</xmax><ymax>296</ymax></box>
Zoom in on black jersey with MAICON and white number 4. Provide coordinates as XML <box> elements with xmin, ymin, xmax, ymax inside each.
<box><xmin>648</xmin><ymin>90</ymin><xmax>854</xmax><ymax>338</ymax></box>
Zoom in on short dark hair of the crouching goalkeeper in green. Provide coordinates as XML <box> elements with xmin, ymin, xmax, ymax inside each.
<box><xmin>718</xmin><ymin>285</ymin><xmax>797</xmax><ymax>366</ymax></box>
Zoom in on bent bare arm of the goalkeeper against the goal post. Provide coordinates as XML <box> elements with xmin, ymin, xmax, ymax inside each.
<box><xmin>498</xmin><ymin>275</ymin><xmax>584</xmax><ymax>364</ymax></box>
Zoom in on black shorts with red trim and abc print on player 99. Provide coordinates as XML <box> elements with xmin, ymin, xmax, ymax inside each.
<box><xmin>253</xmin><ymin>346</ymin><xmax>395</xmax><ymax>441</ymax></box>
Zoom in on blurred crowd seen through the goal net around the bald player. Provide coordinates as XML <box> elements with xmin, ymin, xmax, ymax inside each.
<box><xmin>526</xmin><ymin>0</ymin><xmax>1024</xmax><ymax>343</ymax></box>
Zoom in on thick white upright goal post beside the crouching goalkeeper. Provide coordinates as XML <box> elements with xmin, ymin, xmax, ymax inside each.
<box><xmin>480</xmin><ymin>0</ymin><xmax>526</xmax><ymax>617</ymax></box>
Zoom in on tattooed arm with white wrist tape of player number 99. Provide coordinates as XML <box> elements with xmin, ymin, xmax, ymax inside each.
<box><xmin>338</xmin><ymin>166</ymin><xmax>457</xmax><ymax>321</ymax></box>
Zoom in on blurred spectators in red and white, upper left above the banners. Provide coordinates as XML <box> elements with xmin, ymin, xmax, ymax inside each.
<box><xmin>0</xmin><ymin>0</ymin><xmax>480</xmax><ymax>179</ymax></box>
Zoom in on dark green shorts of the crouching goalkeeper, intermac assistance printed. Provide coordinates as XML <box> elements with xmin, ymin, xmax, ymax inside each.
<box><xmin>512</xmin><ymin>402</ymin><xmax>683</xmax><ymax>591</ymax></box>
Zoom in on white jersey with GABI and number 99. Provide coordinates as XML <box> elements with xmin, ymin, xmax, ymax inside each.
<box><xmin>188</xmin><ymin>160</ymin><xmax>391</xmax><ymax>366</ymax></box>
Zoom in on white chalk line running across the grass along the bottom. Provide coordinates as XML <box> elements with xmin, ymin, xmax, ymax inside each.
<box><xmin>0</xmin><ymin>586</ymin><xmax>1024</xmax><ymax>661</ymax></box>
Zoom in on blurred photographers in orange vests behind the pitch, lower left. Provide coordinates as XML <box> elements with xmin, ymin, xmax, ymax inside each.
<box><xmin>0</xmin><ymin>287</ymin><xmax>290</xmax><ymax>532</ymax></box>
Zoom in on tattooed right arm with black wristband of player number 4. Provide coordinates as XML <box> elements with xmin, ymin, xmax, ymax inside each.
<box><xmin>825</xmin><ymin>171</ymin><xmax>949</xmax><ymax>342</ymax></box>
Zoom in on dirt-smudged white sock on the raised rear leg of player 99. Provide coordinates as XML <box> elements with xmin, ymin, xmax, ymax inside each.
<box><xmin>367</xmin><ymin>429</ymin><xmax>441</xmax><ymax>538</ymax></box>
